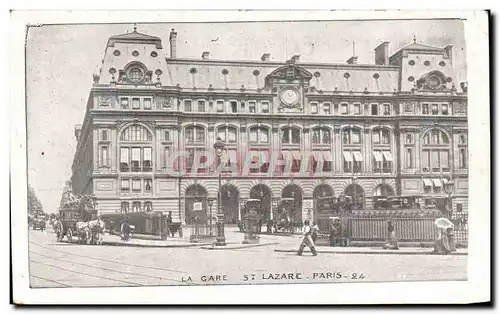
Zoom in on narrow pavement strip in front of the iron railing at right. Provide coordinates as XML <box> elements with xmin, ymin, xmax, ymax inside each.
<box><xmin>274</xmin><ymin>246</ymin><xmax>468</xmax><ymax>255</ymax></box>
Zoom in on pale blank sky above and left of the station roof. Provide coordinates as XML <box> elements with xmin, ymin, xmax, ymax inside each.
<box><xmin>26</xmin><ymin>20</ymin><xmax>467</xmax><ymax>212</ymax></box>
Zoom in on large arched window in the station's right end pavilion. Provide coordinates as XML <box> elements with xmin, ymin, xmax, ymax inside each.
<box><xmin>421</xmin><ymin>129</ymin><xmax>451</xmax><ymax>173</ymax></box>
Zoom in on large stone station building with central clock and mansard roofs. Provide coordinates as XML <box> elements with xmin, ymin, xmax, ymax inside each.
<box><xmin>71</xmin><ymin>26</ymin><xmax>468</xmax><ymax>232</ymax></box>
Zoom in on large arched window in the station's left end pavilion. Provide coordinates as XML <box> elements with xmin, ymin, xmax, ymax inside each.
<box><xmin>120</xmin><ymin>124</ymin><xmax>153</xmax><ymax>172</ymax></box>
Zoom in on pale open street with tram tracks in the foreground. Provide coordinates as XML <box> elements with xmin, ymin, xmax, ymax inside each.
<box><xmin>29</xmin><ymin>230</ymin><xmax>467</xmax><ymax>288</ymax></box>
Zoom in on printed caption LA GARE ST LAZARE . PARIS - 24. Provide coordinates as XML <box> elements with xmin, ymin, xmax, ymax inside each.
<box><xmin>181</xmin><ymin>271</ymin><xmax>365</xmax><ymax>283</ymax></box>
